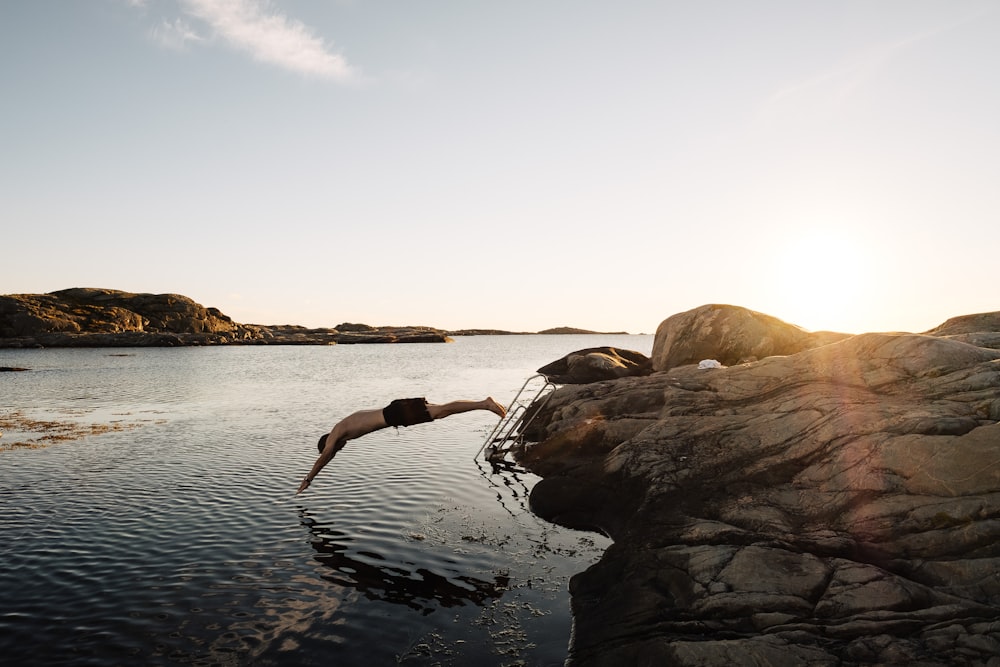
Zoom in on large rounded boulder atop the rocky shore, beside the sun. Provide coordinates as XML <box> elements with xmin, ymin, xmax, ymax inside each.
<box><xmin>652</xmin><ymin>304</ymin><xmax>848</xmax><ymax>371</ymax></box>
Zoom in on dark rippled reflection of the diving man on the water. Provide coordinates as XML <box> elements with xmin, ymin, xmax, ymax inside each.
<box><xmin>299</xmin><ymin>508</ymin><xmax>510</xmax><ymax>615</ymax></box>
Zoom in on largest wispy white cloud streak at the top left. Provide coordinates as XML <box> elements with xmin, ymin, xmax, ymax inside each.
<box><xmin>183</xmin><ymin>0</ymin><xmax>357</xmax><ymax>82</ymax></box>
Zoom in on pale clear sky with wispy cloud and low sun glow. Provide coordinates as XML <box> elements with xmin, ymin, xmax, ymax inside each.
<box><xmin>0</xmin><ymin>0</ymin><xmax>1000</xmax><ymax>333</ymax></box>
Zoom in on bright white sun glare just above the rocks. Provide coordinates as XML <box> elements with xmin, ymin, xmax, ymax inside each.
<box><xmin>771</xmin><ymin>230</ymin><xmax>872</xmax><ymax>333</ymax></box>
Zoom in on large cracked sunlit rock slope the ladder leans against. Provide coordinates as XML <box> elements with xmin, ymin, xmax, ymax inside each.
<box><xmin>521</xmin><ymin>307</ymin><xmax>1000</xmax><ymax>667</ymax></box>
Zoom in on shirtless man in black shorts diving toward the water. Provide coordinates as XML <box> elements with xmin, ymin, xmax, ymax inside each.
<box><xmin>295</xmin><ymin>397</ymin><xmax>507</xmax><ymax>493</ymax></box>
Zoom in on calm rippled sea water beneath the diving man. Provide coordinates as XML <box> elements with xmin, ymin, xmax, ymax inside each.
<box><xmin>0</xmin><ymin>336</ymin><xmax>652</xmax><ymax>666</ymax></box>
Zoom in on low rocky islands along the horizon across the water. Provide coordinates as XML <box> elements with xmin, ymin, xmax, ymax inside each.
<box><xmin>0</xmin><ymin>287</ymin><xmax>624</xmax><ymax>348</ymax></box>
